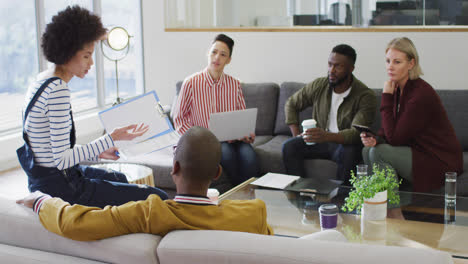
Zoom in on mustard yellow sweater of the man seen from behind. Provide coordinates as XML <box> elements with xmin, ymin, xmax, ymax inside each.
<box><xmin>39</xmin><ymin>195</ymin><xmax>273</xmax><ymax>241</ymax></box>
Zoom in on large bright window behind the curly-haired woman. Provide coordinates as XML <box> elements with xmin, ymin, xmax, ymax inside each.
<box><xmin>0</xmin><ymin>0</ymin><xmax>144</xmax><ymax>133</ymax></box>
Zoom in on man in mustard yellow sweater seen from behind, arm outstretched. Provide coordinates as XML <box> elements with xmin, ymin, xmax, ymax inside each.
<box><xmin>17</xmin><ymin>127</ymin><xmax>273</xmax><ymax>241</ymax></box>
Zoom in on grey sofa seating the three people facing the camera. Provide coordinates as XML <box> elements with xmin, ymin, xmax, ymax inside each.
<box><xmin>89</xmin><ymin>82</ymin><xmax>468</xmax><ymax>195</ymax></box>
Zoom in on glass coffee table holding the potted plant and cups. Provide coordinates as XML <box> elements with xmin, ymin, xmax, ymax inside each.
<box><xmin>219</xmin><ymin>178</ymin><xmax>468</xmax><ymax>263</ymax></box>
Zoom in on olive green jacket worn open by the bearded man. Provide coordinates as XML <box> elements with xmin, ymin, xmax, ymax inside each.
<box><xmin>284</xmin><ymin>76</ymin><xmax>377</xmax><ymax>144</ymax></box>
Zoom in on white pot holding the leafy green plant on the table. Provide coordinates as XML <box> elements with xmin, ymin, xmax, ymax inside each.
<box><xmin>361</xmin><ymin>190</ymin><xmax>387</xmax><ymax>221</ymax></box>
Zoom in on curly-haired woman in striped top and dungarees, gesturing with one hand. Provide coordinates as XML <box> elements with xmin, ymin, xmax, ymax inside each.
<box><xmin>18</xmin><ymin>6</ymin><xmax>167</xmax><ymax>207</ymax></box>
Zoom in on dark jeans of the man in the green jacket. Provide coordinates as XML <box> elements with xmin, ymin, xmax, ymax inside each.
<box><xmin>283</xmin><ymin>137</ymin><xmax>362</xmax><ymax>184</ymax></box>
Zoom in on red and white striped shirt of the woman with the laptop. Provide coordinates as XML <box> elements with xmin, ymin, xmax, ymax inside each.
<box><xmin>174</xmin><ymin>69</ymin><xmax>245</xmax><ymax>135</ymax></box>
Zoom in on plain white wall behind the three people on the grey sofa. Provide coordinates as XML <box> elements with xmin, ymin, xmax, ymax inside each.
<box><xmin>142</xmin><ymin>0</ymin><xmax>468</xmax><ymax>104</ymax></box>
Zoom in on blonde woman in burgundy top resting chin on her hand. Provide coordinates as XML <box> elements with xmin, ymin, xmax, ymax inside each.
<box><xmin>361</xmin><ymin>38</ymin><xmax>463</xmax><ymax>192</ymax></box>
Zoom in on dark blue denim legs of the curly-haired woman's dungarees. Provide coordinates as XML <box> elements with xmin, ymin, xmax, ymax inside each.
<box><xmin>29</xmin><ymin>165</ymin><xmax>168</xmax><ymax>208</ymax></box>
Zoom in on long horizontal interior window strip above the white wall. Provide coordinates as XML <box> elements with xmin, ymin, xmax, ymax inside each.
<box><xmin>165</xmin><ymin>0</ymin><xmax>468</xmax><ymax>29</ymax></box>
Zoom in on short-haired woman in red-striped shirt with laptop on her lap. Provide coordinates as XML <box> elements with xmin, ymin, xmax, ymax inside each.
<box><xmin>174</xmin><ymin>34</ymin><xmax>259</xmax><ymax>185</ymax></box>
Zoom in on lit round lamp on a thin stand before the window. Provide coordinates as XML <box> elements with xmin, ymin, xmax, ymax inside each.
<box><xmin>101</xmin><ymin>27</ymin><xmax>131</xmax><ymax>105</ymax></box>
